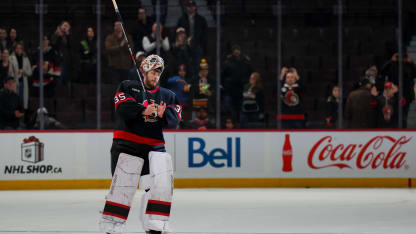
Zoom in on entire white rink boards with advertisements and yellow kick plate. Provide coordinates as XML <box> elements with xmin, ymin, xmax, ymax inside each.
<box><xmin>0</xmin><ymin>131</ymin><xmax>416</xmax><ymax>190</ymax></box>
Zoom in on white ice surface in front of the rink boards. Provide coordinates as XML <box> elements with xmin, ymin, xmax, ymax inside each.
<box><xmin>0</xmin><ymin>189</ymin><xmax>416</xmax><ymax>234</ymax></box>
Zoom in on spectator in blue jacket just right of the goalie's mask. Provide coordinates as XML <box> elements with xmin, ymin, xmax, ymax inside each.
<box><xmin>168</xmin><ymin>64</ymin><xmax>192</xmax><ymax>120</ymax></box>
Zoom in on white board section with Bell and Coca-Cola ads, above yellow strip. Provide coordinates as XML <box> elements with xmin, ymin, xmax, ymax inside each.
<box><xmin>175</xmin><ymin>131</ymin><xmax>416</xmax><ymax>178</ymax></box>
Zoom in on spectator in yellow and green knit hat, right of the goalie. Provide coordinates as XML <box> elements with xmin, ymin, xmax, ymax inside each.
<box><xmin>190</xmin><ymin>59</ymin><xmax>215</xmax><ymax>115</ymax></box>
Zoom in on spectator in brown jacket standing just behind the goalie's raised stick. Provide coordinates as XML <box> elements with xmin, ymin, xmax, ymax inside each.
<box><xmin>105</xmin><ymin>21</ymin><xmax>134</xmax><ymax>83</ymax></box>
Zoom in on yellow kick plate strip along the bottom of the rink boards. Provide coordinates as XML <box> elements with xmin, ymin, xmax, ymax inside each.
<box><xmin>0</xmin><ymin>178</ymin><xmax>416</xmax><ymax>190</ymax></box>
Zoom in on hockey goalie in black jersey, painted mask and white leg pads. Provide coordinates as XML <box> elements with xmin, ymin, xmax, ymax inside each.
<box><xmin>99</xmin><ymin>55</ymin><xmax>182</xmax><ymax>233</ymax></box>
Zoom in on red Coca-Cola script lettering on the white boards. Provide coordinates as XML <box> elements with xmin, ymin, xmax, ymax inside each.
<box><xmin>308</xmin><ymin>136</ymin><xmax>412</xmax><ymax>169</ymax></box>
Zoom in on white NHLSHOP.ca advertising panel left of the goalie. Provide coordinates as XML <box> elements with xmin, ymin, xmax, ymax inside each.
<box><xmin>0</xmin><ymin>132</ymin><xmax>111</xmax><ymax>180</ymax></box>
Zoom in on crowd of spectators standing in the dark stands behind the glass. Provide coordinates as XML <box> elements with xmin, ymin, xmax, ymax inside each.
<box><xmin>0</xmin><ymin>0</ymin><xmax>416</xmax><ymax>130</ymax></box>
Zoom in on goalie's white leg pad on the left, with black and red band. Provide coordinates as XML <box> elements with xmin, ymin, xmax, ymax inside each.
<box><xmin>99</xmin><ymin>153</ymin><xmax>144</xmax><ymax>233</ymax></box>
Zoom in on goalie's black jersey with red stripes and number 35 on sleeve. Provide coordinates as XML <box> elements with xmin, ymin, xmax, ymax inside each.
<box><xmin>113</xmin><ymin>80</ymin><xmax>182</xmax><ymax>146</ymax></box>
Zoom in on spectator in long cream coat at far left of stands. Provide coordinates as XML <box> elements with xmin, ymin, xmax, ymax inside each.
<box><xmin>9</xmin><ymin>43</ymin><xmax>32</xmax><ymax>110</ymax></box>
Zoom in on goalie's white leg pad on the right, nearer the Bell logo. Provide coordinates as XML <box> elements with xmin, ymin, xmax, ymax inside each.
<box><xmin>140</xmin><ymin>151</ymin><xmax>173</xmax><ymax>232</ymax></box>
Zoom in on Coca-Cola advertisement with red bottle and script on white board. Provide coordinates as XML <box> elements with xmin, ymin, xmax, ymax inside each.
<box><xmin>281</xmin><ymin>132</ymin><xmax>416</xmax><ymax>177</ymax></box>
